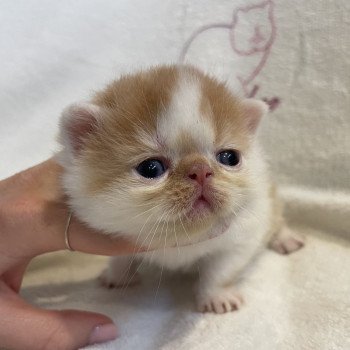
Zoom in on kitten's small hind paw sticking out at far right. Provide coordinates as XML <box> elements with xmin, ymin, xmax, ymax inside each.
<box><xmin>269</xmin><ymin>228</ymin><xmax>305</xmax><ymax>254</ymax></box>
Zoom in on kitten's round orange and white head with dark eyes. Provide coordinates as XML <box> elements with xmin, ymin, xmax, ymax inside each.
<box><xmin>60</xmin><ymin>66</ymin><xmax>267</xmax><ymax>247</ymax></box>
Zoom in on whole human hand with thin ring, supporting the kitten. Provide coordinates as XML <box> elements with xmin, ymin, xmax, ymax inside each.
<box><xmin>0</xmin><ymin>160</ymin><xmax>144</xmax><ymax>350</ymax></box>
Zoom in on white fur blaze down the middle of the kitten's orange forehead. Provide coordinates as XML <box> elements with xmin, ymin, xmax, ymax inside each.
<box><xmin>158</xmin><ymin>73</ymin><xmax>214</xmax><ymax>158</ymax></box>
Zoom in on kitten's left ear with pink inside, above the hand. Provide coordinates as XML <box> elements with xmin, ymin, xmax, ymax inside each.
<box><xmin>60</xmin><ymin>102</ymin><xmax>102</xmax><ymax>156</ymax></box>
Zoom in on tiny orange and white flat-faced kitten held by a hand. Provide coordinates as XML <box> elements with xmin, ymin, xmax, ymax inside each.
<box><xmin>59</xmin><ymin>65</ymin><xmax>303</xmax><ymax>313</ymax></box>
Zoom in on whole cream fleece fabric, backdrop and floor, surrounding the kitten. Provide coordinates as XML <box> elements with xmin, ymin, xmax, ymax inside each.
<box><xmin>0</xmin><ymin>0</ymin><xmax>350</xmax><ymax>349</ymax></box>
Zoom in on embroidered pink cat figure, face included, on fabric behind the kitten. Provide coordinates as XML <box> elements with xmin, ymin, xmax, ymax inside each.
<box><xmin>179</xmin><ymin>0</ymin><xmax>280</xmax><ymax>110</ymax></box>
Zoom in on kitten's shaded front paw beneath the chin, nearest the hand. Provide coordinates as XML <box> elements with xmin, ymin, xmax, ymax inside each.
<box><xmin>99</xmin><ymin>256</ymin><xmax>140</xmax><ymax>288</ymax></box>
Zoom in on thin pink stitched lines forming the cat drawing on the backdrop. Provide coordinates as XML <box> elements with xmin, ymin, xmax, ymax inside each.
<box><xmin>179</xmin><ymin>0</ymin><xmax>280</xmax><ymax>111</ymax></box>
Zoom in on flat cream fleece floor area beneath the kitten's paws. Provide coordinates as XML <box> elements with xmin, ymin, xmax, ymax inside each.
<box><xmin>23</xmin><ymin>228</ymin><xmax>350</xmax><ymax>350</ymax></box>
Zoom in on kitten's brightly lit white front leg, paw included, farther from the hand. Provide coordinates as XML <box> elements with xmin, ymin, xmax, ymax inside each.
<box><xmin>195</xmin><ymin>251</ymin><xmax>251</xmax><ymax>314</ymax></box>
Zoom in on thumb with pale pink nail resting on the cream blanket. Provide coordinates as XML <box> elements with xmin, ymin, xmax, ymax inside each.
<box><xmin>0</xmin><ymin>285</ymin><xmax>117</xmax><ymax>350</ymax></box>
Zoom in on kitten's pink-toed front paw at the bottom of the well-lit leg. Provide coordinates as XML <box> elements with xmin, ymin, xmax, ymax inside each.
<box><xmin>197</xmin><ymin>289</ymin><xmax>243</xmax><ymax>314</ymax></box>
